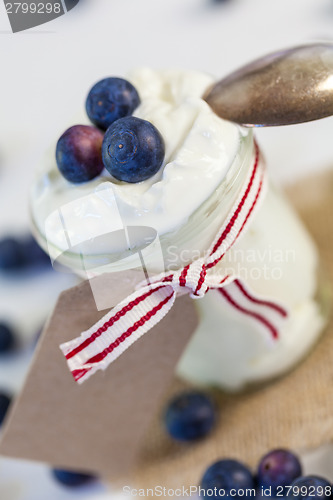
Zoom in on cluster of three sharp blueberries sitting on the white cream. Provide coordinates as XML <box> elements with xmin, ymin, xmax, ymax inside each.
<box><xmin>56</xmin><ymin>78</ymin><xmax>165</xmax><ymax>183</ymax></box>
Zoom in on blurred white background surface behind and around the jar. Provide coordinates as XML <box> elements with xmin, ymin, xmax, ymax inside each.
<box><xmin>0</xmin><ymin>0</ymin><xmax>333</xmax><ymax>500</ymax></box>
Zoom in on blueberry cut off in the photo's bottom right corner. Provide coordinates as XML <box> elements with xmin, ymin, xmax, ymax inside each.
<box><xmin>288</xmin><ymin>476</ymin><xmax>332</xmax><ymax>500</ymax></box>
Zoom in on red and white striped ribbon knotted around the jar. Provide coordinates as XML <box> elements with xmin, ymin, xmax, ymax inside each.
<box><xmin>60</xmin><ymin>146</ymin><xmax>287</xmax><ymax>383</ymax></box>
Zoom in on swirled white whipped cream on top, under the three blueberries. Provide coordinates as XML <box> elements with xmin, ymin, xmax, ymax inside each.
<box><xmin>32</xmin><ymin>69</ymin><xmax>240</xmax><ymax>253</ymax></box>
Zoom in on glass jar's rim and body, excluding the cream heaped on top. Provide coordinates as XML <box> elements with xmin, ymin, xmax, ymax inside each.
<box><xmin>31</xmin><ymin>128</ymin><xmax>326</xmax><ymax>391</ymax></box>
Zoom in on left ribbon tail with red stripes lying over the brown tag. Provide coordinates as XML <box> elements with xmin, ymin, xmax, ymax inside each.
<box><xmin>60</xmin><ymin>283</ymin><xmax>176</xmax><ymax>384</ymax></box>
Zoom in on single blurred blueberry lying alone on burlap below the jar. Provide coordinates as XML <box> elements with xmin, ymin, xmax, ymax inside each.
<box><xmin>165</xmin><ymin>392</ymin><xmax>215</xmax><ymax>441</ymax></box>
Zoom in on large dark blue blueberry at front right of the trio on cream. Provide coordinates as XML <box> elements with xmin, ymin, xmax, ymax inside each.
<box><xmin>102</xmin><ymin>116</ymin><xmax>165</xmax><ymax>182</ymax></box>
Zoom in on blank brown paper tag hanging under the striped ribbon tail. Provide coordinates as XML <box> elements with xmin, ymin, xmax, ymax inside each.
<box><xmin>0</xmin><ymin>273</ymin><xmax>198</xmax><ymax>478</ymax></box>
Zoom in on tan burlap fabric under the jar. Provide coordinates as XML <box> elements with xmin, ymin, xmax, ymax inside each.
<box><xmin>133</xmin><ymin>170</ymin><xmax>333</xmax><ymax>488</ymax></box>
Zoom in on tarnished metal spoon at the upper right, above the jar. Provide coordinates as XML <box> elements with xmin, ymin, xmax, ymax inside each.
<box><xmin>204</xmin><ymin>43</ymin><xmax>333</xmax><ymax>127</ymax></box>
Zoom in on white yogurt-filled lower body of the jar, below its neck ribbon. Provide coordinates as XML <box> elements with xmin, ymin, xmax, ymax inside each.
<box><xmin>177</xmin><ymin>184</ymin><xmax>326</xmax><ymax>391</ymax></box>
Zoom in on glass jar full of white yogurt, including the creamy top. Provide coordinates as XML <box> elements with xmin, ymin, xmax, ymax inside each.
<box><xmin>31</xmin><ymin>69</ymin><xmax>325</xmax><ymax>391</ymax></box>
